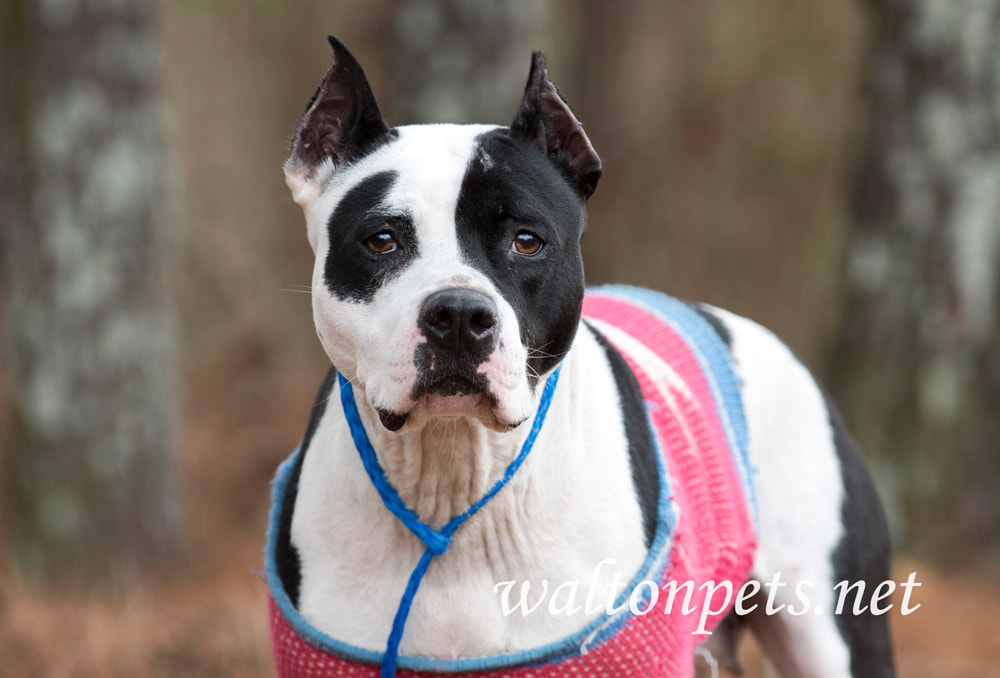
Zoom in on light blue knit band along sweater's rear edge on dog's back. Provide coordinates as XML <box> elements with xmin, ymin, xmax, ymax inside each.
<box><xmin>590</xmin><ymin>285</ymin><xmax>760</xmax><ymax>532</ymax></box>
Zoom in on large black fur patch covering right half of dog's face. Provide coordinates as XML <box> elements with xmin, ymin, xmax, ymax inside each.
<box><xmin>455</xmin><ymin>129</ymin><xmax>586</xmax><ymax>384</ymax></box>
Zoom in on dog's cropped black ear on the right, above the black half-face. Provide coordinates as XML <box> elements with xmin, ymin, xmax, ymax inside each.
<box><xmin>510</xmin><ymin>52</ymin><xmax>601</xmax><ymax>200</ymax></box>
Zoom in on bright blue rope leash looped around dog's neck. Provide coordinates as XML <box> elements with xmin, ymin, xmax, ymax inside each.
<box><xmin>337</xmin><ymin>367</ymin><xmax>562</xmax><ymax>678</ymax></box>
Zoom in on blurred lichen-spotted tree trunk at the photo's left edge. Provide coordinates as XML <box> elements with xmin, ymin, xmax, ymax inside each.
<box><xmin>0</xmin><ymin>0</ymin><xmax>178</xmax><ymax>586</ymax></box>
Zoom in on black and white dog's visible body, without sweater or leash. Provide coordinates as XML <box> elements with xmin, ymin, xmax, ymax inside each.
<box><xmin>276</xmin><ymin>37</ymin><xmax>893</xmax><ymax>677</ymax></box>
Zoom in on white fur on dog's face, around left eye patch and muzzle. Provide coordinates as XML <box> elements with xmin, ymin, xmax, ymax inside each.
<box><xmin>307</xmin><ymin>125</ymin><xmax>535</xmax><ymax>427</ymax></box>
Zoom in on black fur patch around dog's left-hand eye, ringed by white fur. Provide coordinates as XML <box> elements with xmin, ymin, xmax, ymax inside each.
<box><xmin>324</xmin><ymin>170</ymin><xmax>419</xmax><ymax>303</ymax></box>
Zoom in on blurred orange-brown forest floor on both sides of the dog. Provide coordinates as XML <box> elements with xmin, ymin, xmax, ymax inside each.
<box><xmin>0</xmin><ymin>372</ymin><xmax>1000</xmax><ymax>678</ymax></box>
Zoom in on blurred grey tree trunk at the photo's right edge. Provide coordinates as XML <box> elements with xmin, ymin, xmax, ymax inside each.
<box><xmin>832</xmin><ymin>0</ymin><xmax>1000</xmax><ymax>564</ymax></box>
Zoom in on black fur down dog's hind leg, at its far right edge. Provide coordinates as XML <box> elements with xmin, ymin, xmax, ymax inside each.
<box><xmin>823</xmin><ymin>393</ymin><xmax>895</xmax><ymax>678</ymax></box>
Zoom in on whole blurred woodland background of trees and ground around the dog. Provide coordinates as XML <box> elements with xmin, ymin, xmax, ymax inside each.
<box><xmin>0</xmin><ymin>0</ymin><xmax>1000</xmax><ymax>678</ymax></box>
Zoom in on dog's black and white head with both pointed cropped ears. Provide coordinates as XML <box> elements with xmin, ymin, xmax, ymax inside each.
<box><xmin>285</xmin><ymin>36</ymin><xmax>601</xmax><ymax>430</ymax></box>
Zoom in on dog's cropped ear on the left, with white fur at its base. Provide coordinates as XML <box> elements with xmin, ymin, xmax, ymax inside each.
<box><xmin>285</xmin><ymin>35</ymin><xmax>389</xmax><ymax>209</ymax></box>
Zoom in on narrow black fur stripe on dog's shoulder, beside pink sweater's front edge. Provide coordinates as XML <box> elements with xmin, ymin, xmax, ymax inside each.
<box><xmin>585</xmin><ymin>323</ymin><xmax>660</xmax><ymax>548</ymax></box>
